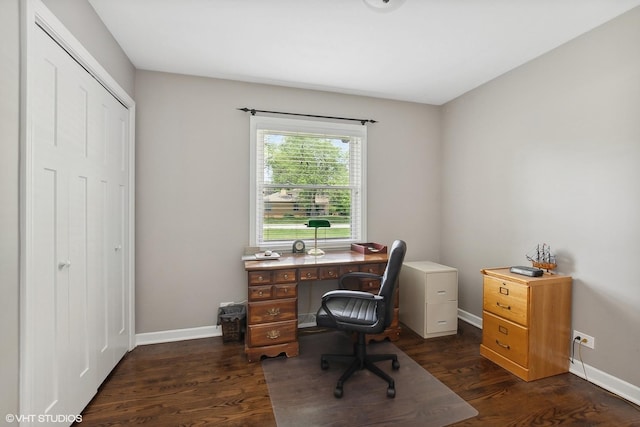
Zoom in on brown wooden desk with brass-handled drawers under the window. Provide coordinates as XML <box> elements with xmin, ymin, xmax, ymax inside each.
<box><xmin>244</xmin><ymin>251</ymin><xmax>400</xmax><ymax>362</ymax></box>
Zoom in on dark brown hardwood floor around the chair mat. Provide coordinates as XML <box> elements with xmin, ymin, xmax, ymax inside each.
<box><xmin>78</xmin><ymin>322</ymin><xmax>640</xmax><ymax>427</ymax></box>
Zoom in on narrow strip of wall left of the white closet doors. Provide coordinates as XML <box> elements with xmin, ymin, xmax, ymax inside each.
<box><xmin>0</xmin><ymin>0</ymin><xmax>20</xmax><ymax>420</ymax></box>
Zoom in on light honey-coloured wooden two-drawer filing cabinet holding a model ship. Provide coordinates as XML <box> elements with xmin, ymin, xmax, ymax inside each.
<box><xmin>480</xmin><ymin>268</ymin><xmax>572</xmax><ymax>381</ymax></box>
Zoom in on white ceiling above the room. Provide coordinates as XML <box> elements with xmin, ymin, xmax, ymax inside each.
<box><xmin>89</xmin><ymin>0</ymin><xmax>640</xmax><ymax>105</ymax></box>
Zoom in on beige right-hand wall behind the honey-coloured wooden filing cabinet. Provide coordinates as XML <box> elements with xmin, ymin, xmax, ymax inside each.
<box><xmin>441</xmin><ymin>8</ymin><xmax>640</xmax><ymax>386</ymax></box>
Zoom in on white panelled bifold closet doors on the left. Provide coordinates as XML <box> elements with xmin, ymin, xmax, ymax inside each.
<box><xmin>24</xmin><ymin>25</ymin><xmax>130</xmax><ymax>425</ymax></box>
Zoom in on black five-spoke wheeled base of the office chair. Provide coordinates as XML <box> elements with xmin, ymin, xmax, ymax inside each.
<box><xmin>320</xmin><ymin>333</ymin><xmax>400</xmax><ymax>398</ymax></box>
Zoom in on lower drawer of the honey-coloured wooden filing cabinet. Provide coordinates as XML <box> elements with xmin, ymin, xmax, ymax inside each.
<box><xmin>482</xmin><ymin>311</ymin><xmax>529</xmax><ymax>368</ymax></box>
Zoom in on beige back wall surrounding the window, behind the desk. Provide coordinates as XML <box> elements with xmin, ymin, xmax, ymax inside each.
<box><xmin>135</xmin><ymin>71</ymin><xmax>440</xmax><ymax>333</ymax></box>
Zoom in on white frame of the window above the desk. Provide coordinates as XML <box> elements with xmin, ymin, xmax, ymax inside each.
<box><xmin>249</xmin><ymin>115</ymin><xmax>367</xmax><ymax>250</ymax></box>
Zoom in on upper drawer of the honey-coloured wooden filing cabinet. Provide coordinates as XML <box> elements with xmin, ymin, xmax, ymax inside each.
<box><xmin>483</xmin><ymin>276</ymin><xmax>529</xmax><ymax>326</ymax></box>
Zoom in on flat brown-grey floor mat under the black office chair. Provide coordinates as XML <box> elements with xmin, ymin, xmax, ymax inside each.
<box><xmin>262</xmin><ymin>332</ymin><xmax>478</xmax><ymax>427</ymax></box>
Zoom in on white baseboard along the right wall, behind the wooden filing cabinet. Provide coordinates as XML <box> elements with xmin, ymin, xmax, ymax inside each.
<box><xmin>458</xmin><ymin>309</ymin><xmax>640</xmax><ymax>405</ymax></box>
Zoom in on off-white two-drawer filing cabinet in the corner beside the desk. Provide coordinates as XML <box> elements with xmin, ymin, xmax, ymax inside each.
<box><xmin>399</xmin><ymin>261</ymin><xmax>458</xmax><ymax>338</ymax></box>
